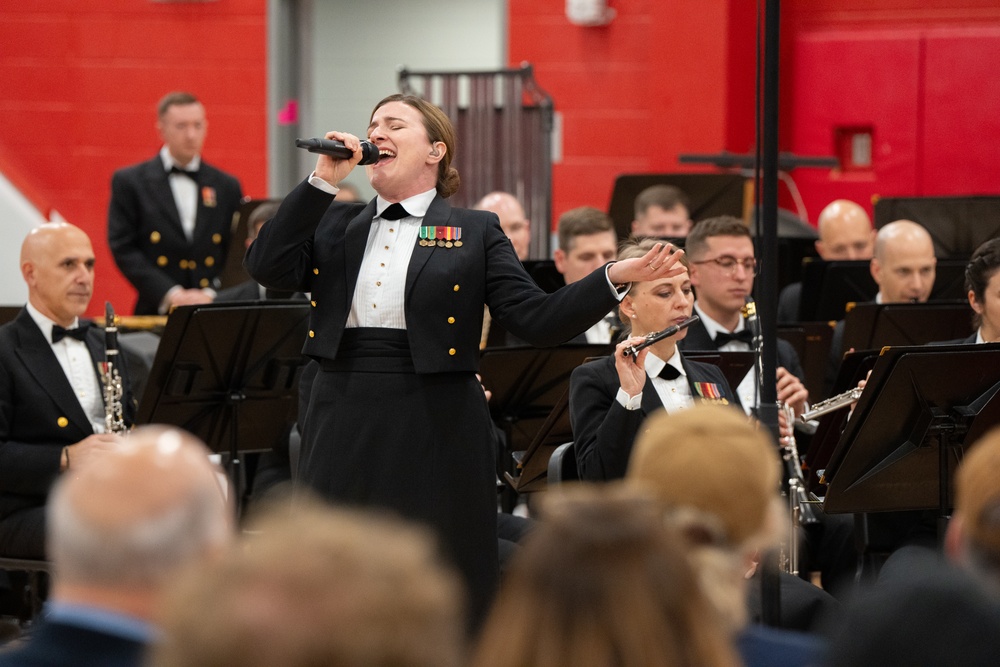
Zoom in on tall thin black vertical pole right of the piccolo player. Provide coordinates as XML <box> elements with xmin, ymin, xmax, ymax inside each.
<box><xmin>756</xmin><ymin>0</ymin><xmax>781</xmax><ymax>626</ymax></box>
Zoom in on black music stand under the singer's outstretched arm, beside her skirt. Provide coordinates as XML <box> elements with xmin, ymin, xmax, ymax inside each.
<box><xmin>479</xmin><ymin>344</ymin><xmax>614</xmax><ymax>511</ymax></box>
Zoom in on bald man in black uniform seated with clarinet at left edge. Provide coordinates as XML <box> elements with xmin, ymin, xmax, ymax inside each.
<box><xmin>0</xmin><ymin>222</ymin><xmax>134</xmax><ymax>559</ymax></box>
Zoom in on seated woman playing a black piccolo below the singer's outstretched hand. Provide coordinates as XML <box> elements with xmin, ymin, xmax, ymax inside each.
<box><xmin>569</xmin><ymin>239</ymin><xmax>738</xmax><ymax>481</ymax></box>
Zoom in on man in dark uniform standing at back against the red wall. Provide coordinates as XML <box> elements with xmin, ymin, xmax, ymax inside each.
<box><xmin>108</xmin><ymin>92</ymin><xmax>243</xmax><ymax>315</ymax></box>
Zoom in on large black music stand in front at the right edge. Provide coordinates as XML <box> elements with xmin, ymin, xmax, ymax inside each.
<box><xmin>824</xmin><ymin>344</ymin><xmax>1000</xmax><ymax>527</ymax></box>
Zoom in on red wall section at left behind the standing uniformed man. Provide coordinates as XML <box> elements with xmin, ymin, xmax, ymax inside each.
<box><xmin>0</xmin><ymin>0</ymin><xmax>267</xmax><ymax>314</ymax></box>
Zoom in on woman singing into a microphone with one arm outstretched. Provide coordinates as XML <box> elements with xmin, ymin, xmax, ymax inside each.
<box><xmin>246</xmin><ymin>95</ymin><xmax>680</xmax><ymax>621</ymax></box>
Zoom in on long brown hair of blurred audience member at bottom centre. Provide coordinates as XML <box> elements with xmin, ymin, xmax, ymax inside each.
<box><xmin>471</xmin><ymin>484</ymin><xmax>739</xmax><ymax>667</ymax></box>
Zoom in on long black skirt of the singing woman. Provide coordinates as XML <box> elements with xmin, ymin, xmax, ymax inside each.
<box><xmin>297</xmin><ymin>329</ymin><xmax>499</xmax><ymax>619</ymax></box>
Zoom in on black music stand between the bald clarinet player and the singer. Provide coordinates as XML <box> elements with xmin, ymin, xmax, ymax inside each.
<box><xmin>136</xmin><ymin>301</ymin><xmax>310</xmax><ymax>510</ymax></box>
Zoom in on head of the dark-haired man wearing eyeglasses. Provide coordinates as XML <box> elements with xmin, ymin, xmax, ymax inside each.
<box><xmin>684</xmin><ymin>215</ymin><xmax>757</xmax><ymax>328</ymax></box>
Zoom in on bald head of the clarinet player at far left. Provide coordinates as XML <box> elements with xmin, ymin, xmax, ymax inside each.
<box><xmin>21</xmin><ymin>222</ymin><xmax>95</xmax><ymax>327</ymax></box>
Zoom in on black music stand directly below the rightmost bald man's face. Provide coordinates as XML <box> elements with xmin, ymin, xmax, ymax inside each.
<box><xmin>842</xmin><ymin>301</ymin><xmax>972</xmax><ymax>350</ymax></box>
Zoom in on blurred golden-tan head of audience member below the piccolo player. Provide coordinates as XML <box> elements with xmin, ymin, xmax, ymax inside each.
<box><xmin>625</xmin><ymin>405</ymin><xmax>787</xmax><ymax>633</ymax></box>
